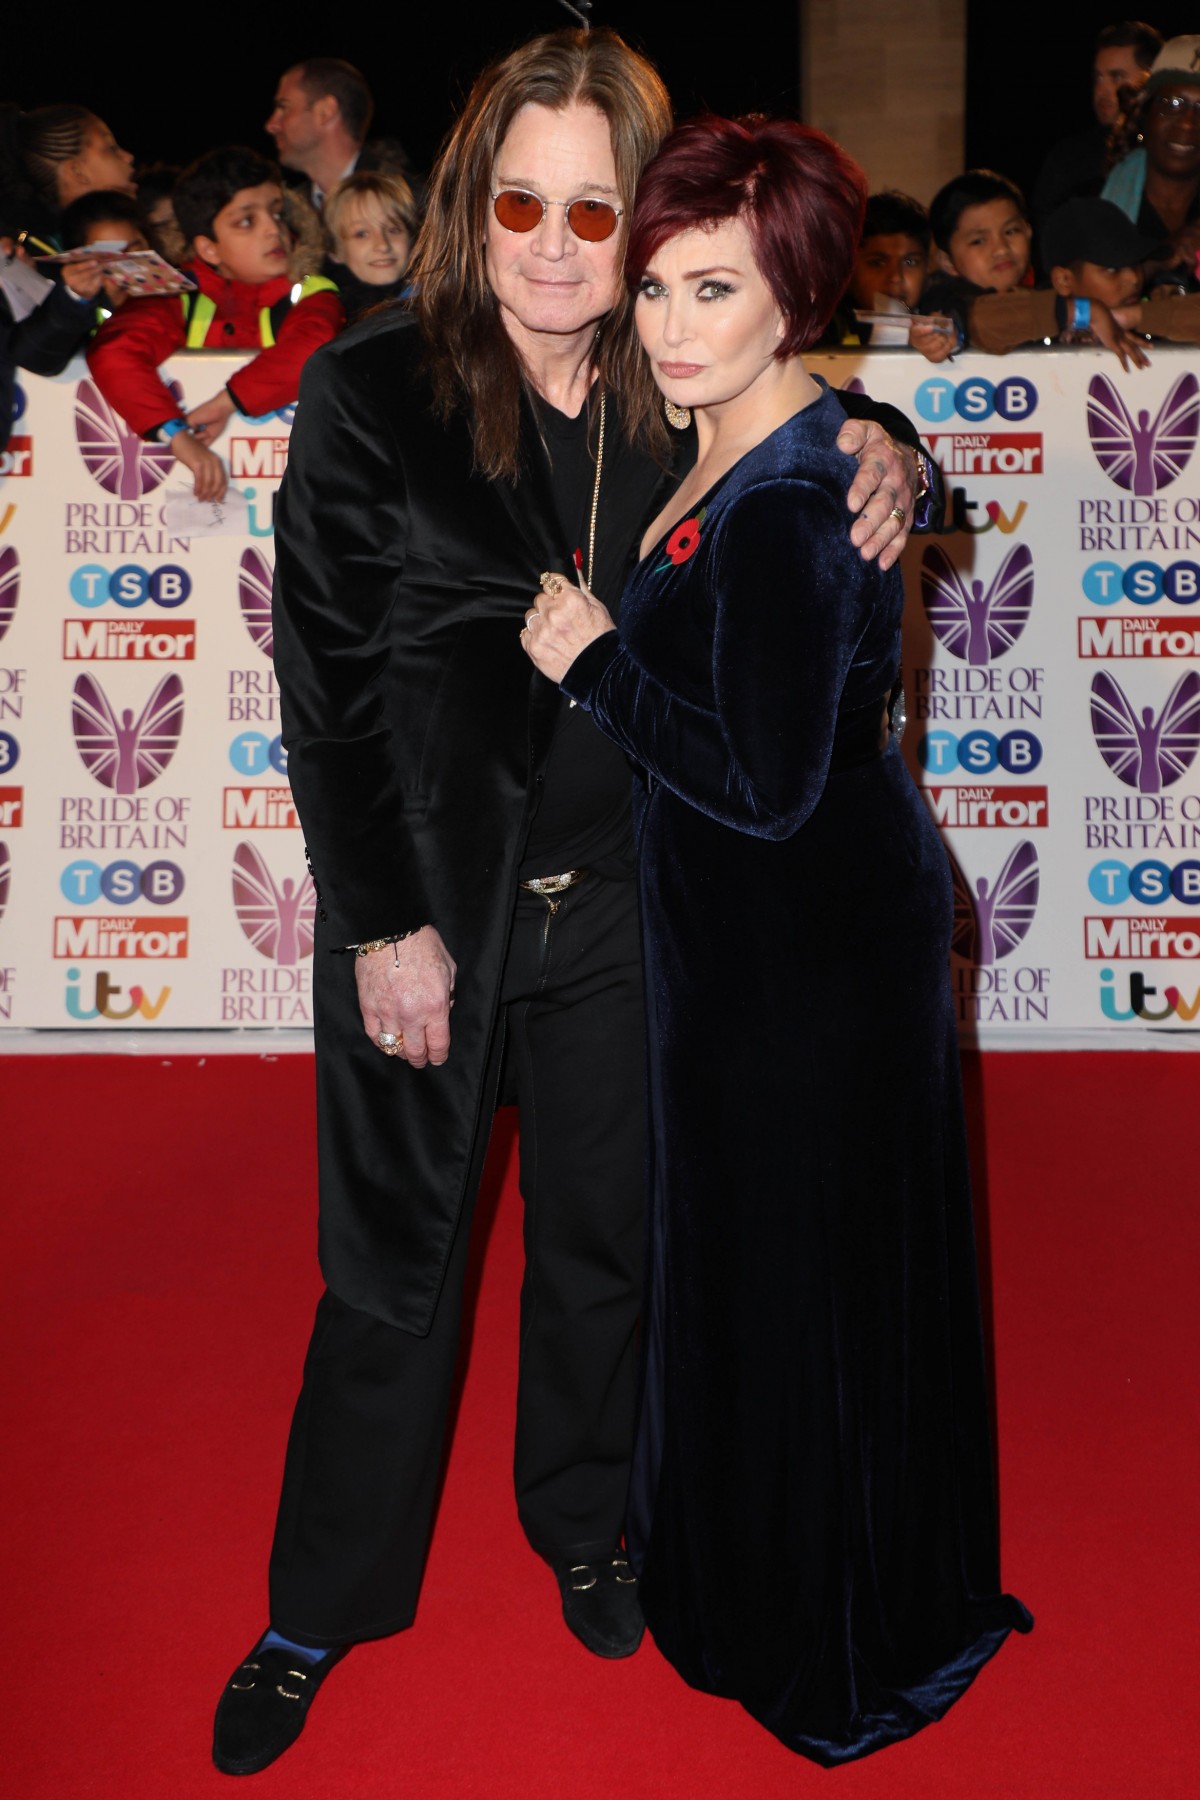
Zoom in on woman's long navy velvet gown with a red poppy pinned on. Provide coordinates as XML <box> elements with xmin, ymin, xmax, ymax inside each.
<box><xmin>563</xmin><ymin>391</ymin><xmax>1031</xmax><ymax>1764</ymax></box>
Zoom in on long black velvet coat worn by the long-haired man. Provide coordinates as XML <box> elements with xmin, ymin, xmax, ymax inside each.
<box><xmin>273</xmin><ymin>311</ymin><xmax>935</xmax><ymax>1332</ymax></box>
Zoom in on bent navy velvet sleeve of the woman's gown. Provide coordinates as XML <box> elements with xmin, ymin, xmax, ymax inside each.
<box><xmin>561</xmin><ymin>479</ymin><xmax>894</xmax><ymax>839</ymax></box>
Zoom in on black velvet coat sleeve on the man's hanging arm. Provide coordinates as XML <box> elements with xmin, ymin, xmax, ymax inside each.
<box><xmin>273</xmin><ymin>342</ymin><xmax>432</xmax><ymax>943</ymax></box>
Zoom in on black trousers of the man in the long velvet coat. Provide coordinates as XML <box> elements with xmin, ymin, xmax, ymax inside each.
<box><xmin>270</xmin><ymin>875</ymin><xmax>644</xmax><ymax>1647</ymax></box>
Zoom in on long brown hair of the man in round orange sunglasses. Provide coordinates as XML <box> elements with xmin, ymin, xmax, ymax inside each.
<box><xmin>410</xmin><ymin>31</ymin><xmax>671</xmax><ymax>481</ymax></box>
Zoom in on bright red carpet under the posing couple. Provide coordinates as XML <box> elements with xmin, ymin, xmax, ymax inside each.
<box><xmin>0</xmin><ymin>1053</ymin><xmax>1200</xmax><ymax>1800</ymax></box>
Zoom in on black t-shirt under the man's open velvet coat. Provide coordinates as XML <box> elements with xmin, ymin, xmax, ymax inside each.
<box><xmin>520</xmin><ymin>396</ymin><xmax>680</xmax><ymax>880</ymax></box>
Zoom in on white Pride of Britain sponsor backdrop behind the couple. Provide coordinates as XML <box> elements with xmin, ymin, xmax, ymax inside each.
<box><xmin>0</xmin><ymin>349</ymin><xmax>1200</xmax><ymax>1046</ymax></box>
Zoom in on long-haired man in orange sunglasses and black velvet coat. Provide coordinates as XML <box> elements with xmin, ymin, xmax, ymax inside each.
<box><xmin>214</xmin><ymin>31</ymin><xmax>916</xmax><ymax>1773</ymax></box>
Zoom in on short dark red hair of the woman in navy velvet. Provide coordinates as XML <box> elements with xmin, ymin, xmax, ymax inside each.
<box><xmin>624</xmin><ymin>117</ymin><xmax>867</xmax><ymax>356</ymax></box>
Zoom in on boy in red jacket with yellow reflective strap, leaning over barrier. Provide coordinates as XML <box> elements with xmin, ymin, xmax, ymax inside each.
<box><xmin>88</xmin><ymin>148</ymin><xmax>345</xmax><ymax>500</ymax></box>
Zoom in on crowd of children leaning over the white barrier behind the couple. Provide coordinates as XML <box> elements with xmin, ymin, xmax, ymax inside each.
<box><xmin>0</xmin><ymin>34</ymin><xmax>1200</xmax><ymax>500</ymax></box>
